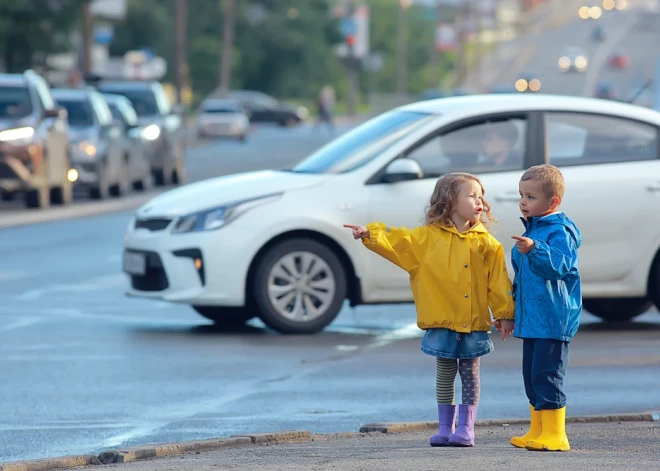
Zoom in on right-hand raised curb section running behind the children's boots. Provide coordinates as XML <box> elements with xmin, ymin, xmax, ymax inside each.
<box><xmin>360</xmin><ymin>412</ymin><xmax>660</xmax><ymax>433</ymax></box>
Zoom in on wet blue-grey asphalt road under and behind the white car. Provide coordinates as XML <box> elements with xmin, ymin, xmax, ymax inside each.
<box><xmin>0</xmin><ymin>1</ymin><xmax>660</xmax><ymax>462</ymax></box>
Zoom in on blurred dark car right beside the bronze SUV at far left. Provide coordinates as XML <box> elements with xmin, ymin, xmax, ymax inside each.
<box><xmin>53</xmin><ymin>88</ymin><xmax>131</xmax><ymax>199</ymax></box>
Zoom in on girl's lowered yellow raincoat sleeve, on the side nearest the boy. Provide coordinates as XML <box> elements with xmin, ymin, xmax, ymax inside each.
<box><xmin>486</xmin><ymin>238</ymin><xmax>515</xmax><ymax>320</ymax></box>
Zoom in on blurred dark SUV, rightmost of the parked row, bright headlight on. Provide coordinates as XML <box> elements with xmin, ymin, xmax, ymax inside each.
<box><xmin>97</xmin><ymin>80</ymin><xmax>185</xmax><ymax>186</ymax></box>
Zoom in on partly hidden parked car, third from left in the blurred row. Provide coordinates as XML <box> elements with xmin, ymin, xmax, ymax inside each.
<box><xmin>103</xmin><ymin>93</ymin><xmax>152</xmax><ymax>191</ymax></box>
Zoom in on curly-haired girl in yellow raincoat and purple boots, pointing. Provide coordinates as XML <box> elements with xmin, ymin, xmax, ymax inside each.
<box><xmin>344</xmin><ymin>173</ymin><xmax>514</xmax><ymax>446</ymax></box>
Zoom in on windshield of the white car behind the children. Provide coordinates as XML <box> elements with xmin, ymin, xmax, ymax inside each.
<box><xmin>291</xmin><ymin>111</ymin><xmax>437</xmax><ymax>173</ymax></box>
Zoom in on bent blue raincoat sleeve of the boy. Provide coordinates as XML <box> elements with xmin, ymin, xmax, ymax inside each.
<box><xmin>527</xmin><ymin>230</ymin><xmax>577</xmax><ymax>281</ymax></box>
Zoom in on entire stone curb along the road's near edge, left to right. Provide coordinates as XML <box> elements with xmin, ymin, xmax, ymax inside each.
<box><xmin>0</xmin><ymin>412</ymin><xmax>660</xmax><ymax>471</ymax></box>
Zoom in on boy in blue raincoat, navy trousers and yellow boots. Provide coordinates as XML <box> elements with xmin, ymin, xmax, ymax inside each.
<box><xmin>511</xmin><ymin>165</ymin><xmax>582</xmax><ymax>451</ymax></box>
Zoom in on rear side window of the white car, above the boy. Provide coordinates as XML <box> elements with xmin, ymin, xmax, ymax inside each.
<box><xmin>545</xmin><ymin>113</ymin><xmax>658</xmax><ymax>167</ymax></box>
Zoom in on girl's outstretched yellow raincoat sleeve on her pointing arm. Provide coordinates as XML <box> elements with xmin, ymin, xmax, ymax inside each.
<box><xmin>362</xmin><ymin>222</ymin><xmax>431</xmax><ymax>273</ymax></box>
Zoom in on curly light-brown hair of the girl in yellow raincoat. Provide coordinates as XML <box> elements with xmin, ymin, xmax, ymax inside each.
<box><xmin>425</xmin><ymin>172</ymin><xmax>497</xmax><ymax>228</ymax></box>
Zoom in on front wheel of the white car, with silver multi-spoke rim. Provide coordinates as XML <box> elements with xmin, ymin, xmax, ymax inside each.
<box><xmin>252</xmin><ymin>239</ymin><xmax>346</xmax><ymax>334</ymax></box>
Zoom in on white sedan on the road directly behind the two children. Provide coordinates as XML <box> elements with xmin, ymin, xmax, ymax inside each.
<box><xmin>124</xmin><ymin>94</ymin><xmax>660</xmax><ymax>333</ymax></box>
